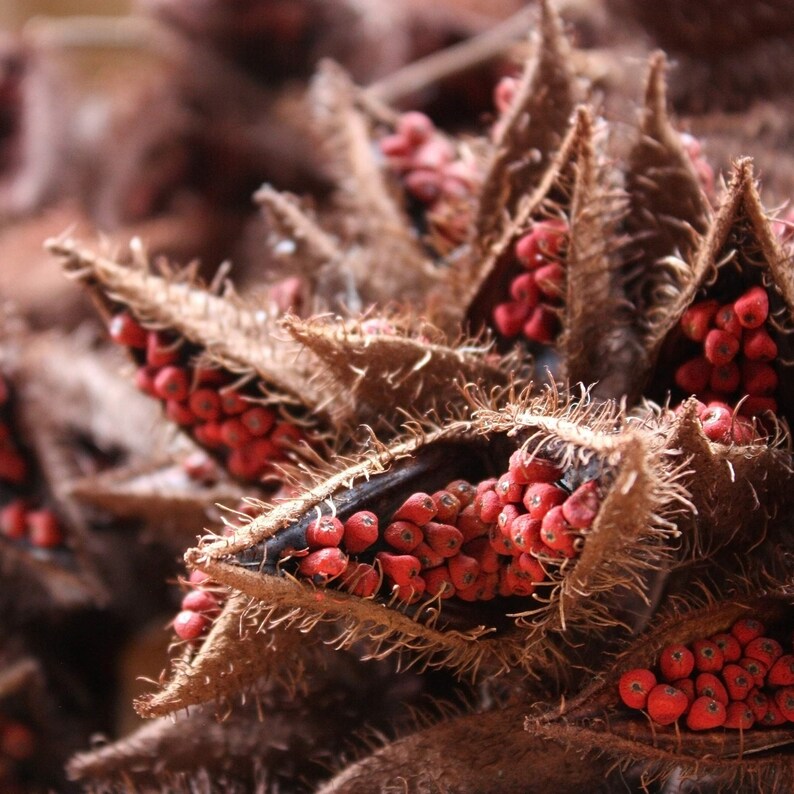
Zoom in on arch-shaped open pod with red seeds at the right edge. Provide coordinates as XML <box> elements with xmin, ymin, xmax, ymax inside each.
<box><xmin>644</xmin><ymin>160</ymin><xmax>794</xmax><ymax>436</ymax></box>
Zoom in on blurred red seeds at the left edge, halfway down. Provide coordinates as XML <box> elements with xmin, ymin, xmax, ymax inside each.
<box><xmin>0</xmin><ymin>377</ymin><xmax>64</xmax><ymax>549</ymax></box>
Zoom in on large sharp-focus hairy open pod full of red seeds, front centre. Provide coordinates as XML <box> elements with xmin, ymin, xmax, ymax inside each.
<box><xmin>139</xmin><ymin>392</ymin><xmax>685</xmax><ymax>707</ymax></box>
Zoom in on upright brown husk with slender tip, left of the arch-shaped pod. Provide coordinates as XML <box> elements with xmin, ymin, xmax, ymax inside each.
<box><xmin>624</xmin><ymin>52</ymin><xmax>711</xmax><ymax>334</ymax></box>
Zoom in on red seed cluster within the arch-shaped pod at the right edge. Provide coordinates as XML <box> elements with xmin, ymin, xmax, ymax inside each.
<box><xmin>675</xmin><ymin>286</ymin><xmax>778</xmax><ymax>443</ymax></box>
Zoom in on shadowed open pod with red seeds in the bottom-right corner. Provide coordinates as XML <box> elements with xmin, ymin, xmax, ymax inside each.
<box><xmin>527</xmin><ymin>593</ymin><xmax>794</xmax><ymax>791</ymax></box>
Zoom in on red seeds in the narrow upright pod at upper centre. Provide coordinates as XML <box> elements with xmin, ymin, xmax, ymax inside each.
<box><xmin>493</xmin><ymin>218</ymin><xmax>568</xmax><ymax>345</ymax></box>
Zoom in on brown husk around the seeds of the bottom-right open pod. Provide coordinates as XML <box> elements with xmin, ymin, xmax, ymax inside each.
<box><xmin>526</xmin><ymin>592</ymin><xmax>794</xmax><ymax>791</ymax></box>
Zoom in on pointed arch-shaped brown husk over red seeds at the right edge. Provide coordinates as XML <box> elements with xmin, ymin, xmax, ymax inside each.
<box><xmin>637</xmin><ymin>159</ymin><xmax>794</xmax><ymax>416</ymax></box>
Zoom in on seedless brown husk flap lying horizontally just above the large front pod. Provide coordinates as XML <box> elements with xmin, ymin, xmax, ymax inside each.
<box><xmin>283</xmin><ymin>316</ymin><xmax>516</xmax><ymax>428</ymax></box>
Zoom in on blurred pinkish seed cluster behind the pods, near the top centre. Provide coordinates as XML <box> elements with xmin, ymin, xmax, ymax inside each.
<box><xmin>380</xmin><ymin>111</ymin><xmax>479</xmax><ymax>220</ymax></box>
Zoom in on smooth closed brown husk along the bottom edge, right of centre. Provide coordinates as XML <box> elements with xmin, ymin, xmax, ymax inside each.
<box><xmin>317</xmin><ymin>705</ymin><xmax>615</xmax><ymax>794</ymax></box>
